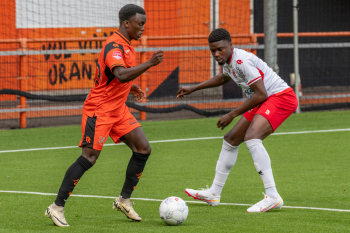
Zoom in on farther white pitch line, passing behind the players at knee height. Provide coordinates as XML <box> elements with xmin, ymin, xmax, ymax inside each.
<box><xmin>0</xmin><ymin>128</ymin><xmax>350</xmax><ymax>153</ymax></box>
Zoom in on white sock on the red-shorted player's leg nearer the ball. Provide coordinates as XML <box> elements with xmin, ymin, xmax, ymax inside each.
<box><xmin>210</xmin><ymin>139</ymin><xmax>239</xmax><ymax>196</ymax></box>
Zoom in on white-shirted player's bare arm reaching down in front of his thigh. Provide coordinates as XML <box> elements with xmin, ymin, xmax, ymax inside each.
<box><xmin>217</xmin><ymin>79</ymin><xmax>268</xmax><ymax>130</ymax></box>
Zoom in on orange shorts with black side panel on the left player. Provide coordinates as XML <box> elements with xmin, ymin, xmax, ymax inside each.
<box><xmin>79</xmin><ymin>110</ymin><xmax>141</xmax><ymax>150</ymax></box>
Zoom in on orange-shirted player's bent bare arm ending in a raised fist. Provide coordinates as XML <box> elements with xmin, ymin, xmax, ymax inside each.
<box><xmin>112</xmin><ymin>50</ymin><xmax>163</xmax><ymax>83</ymax></box>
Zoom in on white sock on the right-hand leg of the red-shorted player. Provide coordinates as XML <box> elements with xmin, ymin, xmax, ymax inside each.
<box><xmin>245</xmin><ymin>139</ymin><xmax>278</xmax><ymax>198</ymax></box>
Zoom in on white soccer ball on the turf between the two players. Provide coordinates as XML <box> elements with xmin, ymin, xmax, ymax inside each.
<box><xmin>159</xmin><ymin>197</ymin><xmax>188</xmax><ymax>226</ymax></box>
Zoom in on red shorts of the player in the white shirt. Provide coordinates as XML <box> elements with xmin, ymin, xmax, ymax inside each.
<box><xmin>243</xmin><ymin>88</ymin><xmax>298</xmax><ymax>131</ymax></box>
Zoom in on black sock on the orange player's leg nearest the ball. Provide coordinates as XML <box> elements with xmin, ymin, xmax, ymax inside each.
<box><xmin>120</xmin><ymin>152</ymin><xmax>149</xmax><ymax>199</ymax></box>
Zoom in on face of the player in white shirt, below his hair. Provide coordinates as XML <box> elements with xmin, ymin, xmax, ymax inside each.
<box><xmin>209</xmin><ymin>40</ymin><xmax>233</xmax><ymax>66</ymax></box>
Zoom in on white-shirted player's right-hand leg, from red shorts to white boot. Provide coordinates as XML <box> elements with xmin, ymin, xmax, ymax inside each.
<box><xmin>244</xmin><ymin>91</ymin><xmax>298</xmax><ymax>212</ymax></box>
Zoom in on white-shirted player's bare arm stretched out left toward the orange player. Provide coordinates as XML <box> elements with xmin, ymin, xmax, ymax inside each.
<box><xmin>176</xmin><ymin>74</ymin><xmax>231</xmax><ymax>99</ymax></box>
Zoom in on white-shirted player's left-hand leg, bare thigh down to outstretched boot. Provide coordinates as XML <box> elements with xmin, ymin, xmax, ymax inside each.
<box><xmin>185</xmin><ymin>117</ymin><xmax>250</xmax><ymax>206</ymax></box>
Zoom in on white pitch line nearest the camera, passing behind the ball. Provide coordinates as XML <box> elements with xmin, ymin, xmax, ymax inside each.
<box><xmin>0</xmin><ymin>190</ymin><xmax>350</xmax><ymax>212</ymax></box>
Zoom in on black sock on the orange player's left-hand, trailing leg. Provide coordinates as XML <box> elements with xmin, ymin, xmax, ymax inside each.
<box><xmin>55</xmin><ymin>156</ymin><xmax>93</xmax><ymax>206</ymax></box>
